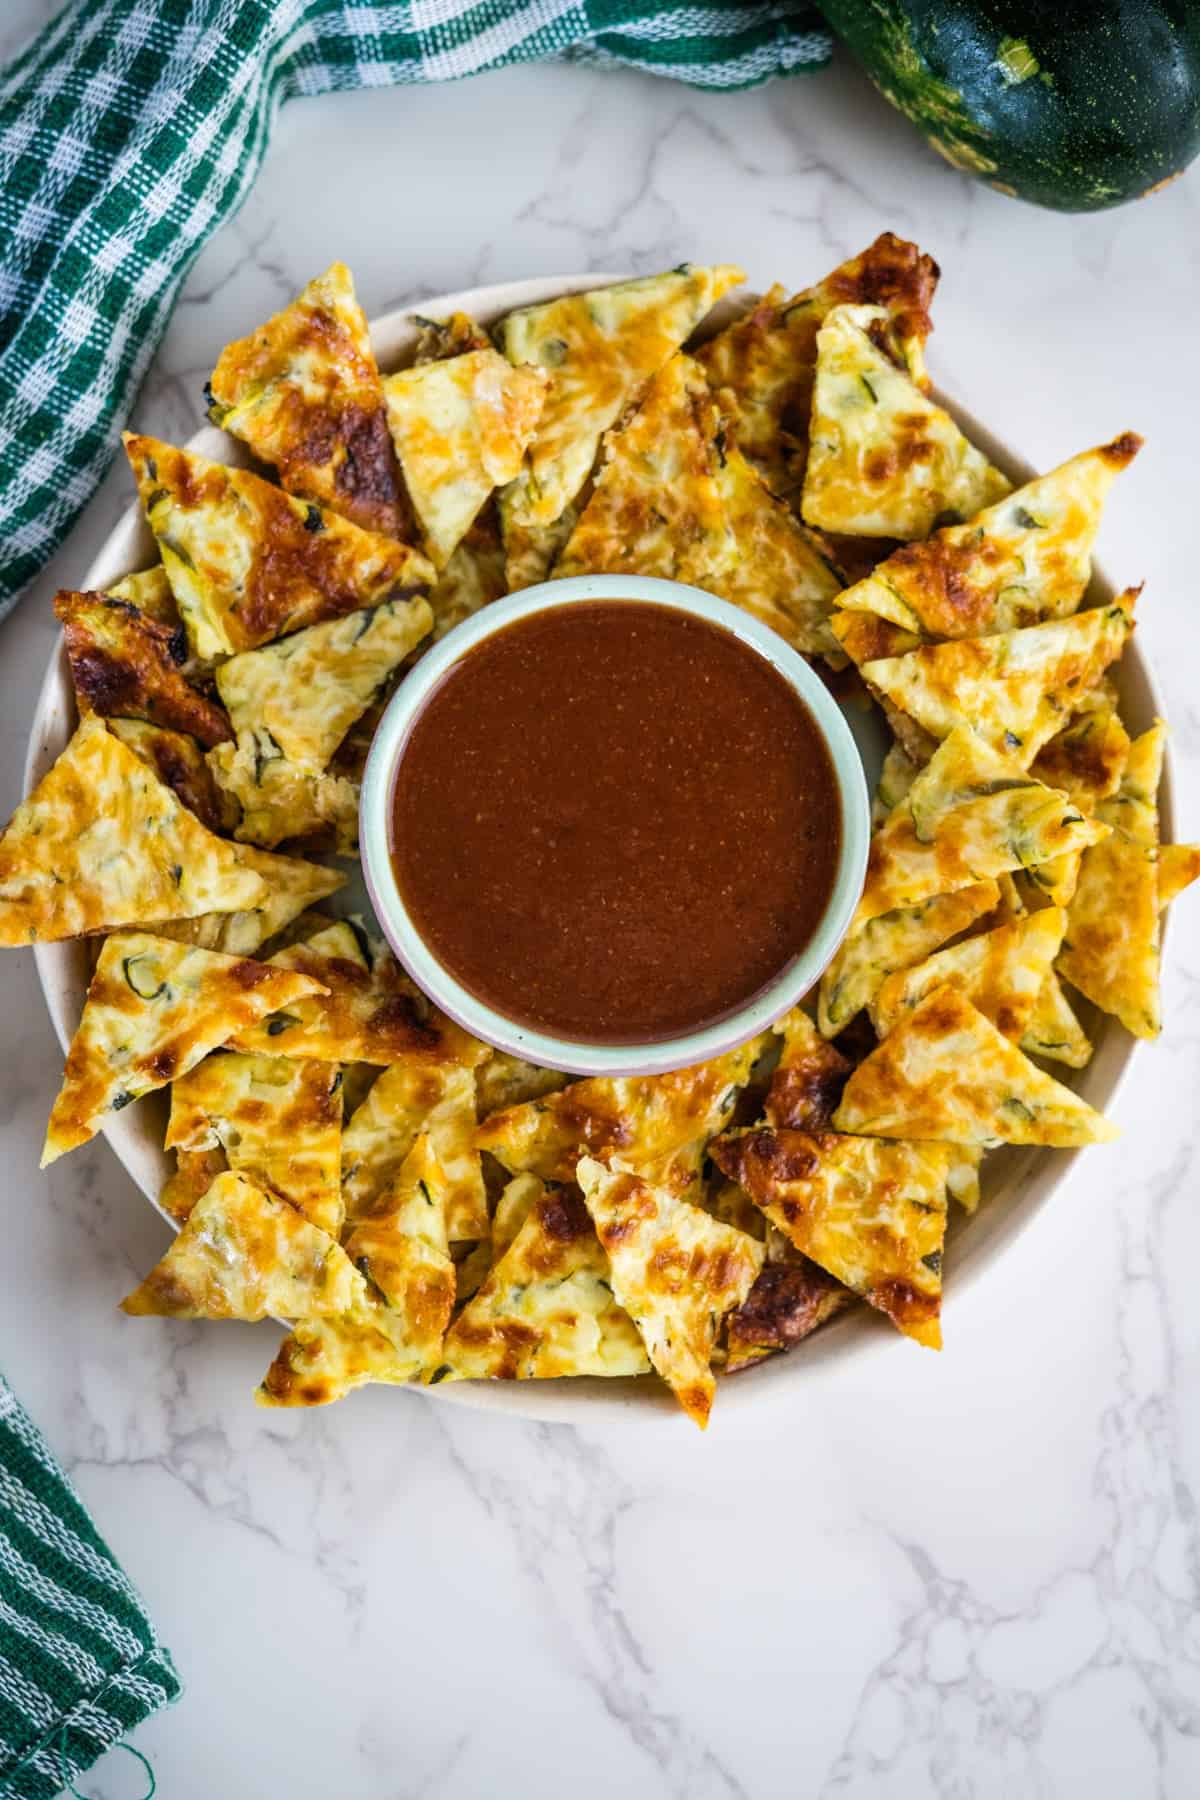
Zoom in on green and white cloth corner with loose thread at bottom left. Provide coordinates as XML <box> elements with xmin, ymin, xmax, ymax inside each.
<box><xmin>0</xmin><ymin>1375</ymin><xmax>180</xmax><ymax>1800</ymax></box>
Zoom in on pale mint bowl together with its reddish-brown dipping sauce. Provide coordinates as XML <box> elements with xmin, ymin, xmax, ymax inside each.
<box><xmin>360</xmin><ymin>576</ymin><xmax>871</xmax><ymax>1075</ymax></box>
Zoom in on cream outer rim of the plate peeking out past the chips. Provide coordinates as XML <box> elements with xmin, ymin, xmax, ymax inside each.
<box><xmin>22</xmin><ymin>270</ymin><xmax>1175</xmax><ymax>1424</ymax></box>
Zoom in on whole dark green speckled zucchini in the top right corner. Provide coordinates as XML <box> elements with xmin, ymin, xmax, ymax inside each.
<box><xmin>822</xmin><ymin>0</ymin><xmax>1200</xmax><ymax>212</ymax></box>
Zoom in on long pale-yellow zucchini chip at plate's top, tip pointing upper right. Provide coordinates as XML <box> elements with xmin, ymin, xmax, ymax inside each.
<box><xmin>497</xmin><ymin>263</ymin><xmax>745</xmax><ymax>526</ymax></box>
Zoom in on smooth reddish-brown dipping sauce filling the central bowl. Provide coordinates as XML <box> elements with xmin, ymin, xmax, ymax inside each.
<box><xmin>390</xmin><ymin>599</ymin><xmax>842</xmax><ymax>1044</ymax></box>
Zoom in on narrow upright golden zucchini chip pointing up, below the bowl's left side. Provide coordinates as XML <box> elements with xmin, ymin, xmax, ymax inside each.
<box><xmin>345</xmin><ymin>1132</ymin><xmax>455</xmax><ymax>1379</ymax></box>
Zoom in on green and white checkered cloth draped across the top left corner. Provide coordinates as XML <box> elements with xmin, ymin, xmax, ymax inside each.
<box><xmin>0</xmin><ymin>0</ymin><xmax>829</xmax><ymax>617</ymax></box>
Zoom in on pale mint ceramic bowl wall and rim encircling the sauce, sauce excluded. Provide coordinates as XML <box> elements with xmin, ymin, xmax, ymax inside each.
<box><xmin>360</xmin><ymin>574</ymin><xmax>871</xmax><ymax>1075</ymax></box>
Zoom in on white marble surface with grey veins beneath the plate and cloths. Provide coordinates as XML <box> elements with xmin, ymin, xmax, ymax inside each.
<box><xmin>0</xmin><ymin>10</ymin><xmax>1200</xmax><ymax>1800</ymax></box>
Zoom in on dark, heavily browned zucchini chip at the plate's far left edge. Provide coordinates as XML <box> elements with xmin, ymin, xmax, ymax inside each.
<box><xmin>54</xmin><ymin>592</ymin><xmax>232</xmax><ymax>747</ymax></box>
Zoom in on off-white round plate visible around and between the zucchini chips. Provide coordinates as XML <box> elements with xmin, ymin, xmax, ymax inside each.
<box><xmin>25</xmin><ymin>274</ymin><xmax>1173</xmax><ymax>1422</ymax></box>
